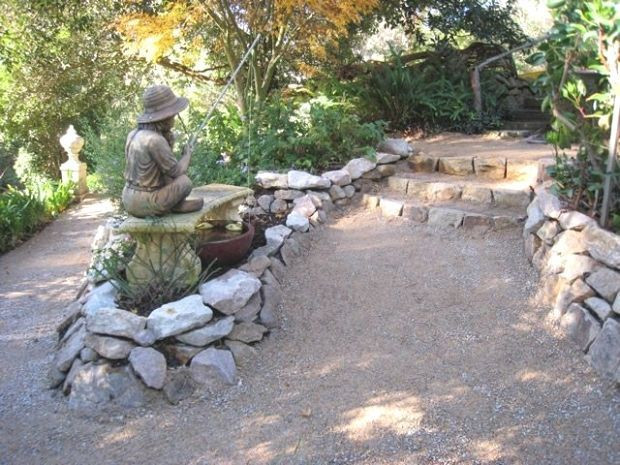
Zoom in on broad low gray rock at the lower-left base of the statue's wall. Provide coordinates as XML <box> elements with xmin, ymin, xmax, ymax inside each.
<box><xmin>69</xmin><ymin>363</ymin><xmax>146</xmax><ymax>413</ymax></box>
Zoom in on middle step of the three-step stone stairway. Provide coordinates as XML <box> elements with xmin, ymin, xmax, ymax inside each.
<box><xmin>387</xmin><ymin>175</ymin><xmax>531</xmax><ymax>212</ymax></box>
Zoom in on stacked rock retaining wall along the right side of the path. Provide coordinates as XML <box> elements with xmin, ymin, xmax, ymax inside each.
<box><xmin>523</xmin><ymin>186</ymin><xmax>620</xmax><ymax>382</ymax></box>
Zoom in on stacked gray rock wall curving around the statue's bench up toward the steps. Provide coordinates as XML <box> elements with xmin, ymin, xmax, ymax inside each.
<box><xmin>49</xmin><ymin>139</ymin><xmax>411</xmax><ymax>411</ymax></box>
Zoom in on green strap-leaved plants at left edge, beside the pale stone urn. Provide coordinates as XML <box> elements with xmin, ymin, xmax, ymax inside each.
<box><xmin>0</xmin><ymin>182</ymin><xmax>74</xmax><ymax>253</ymax></box>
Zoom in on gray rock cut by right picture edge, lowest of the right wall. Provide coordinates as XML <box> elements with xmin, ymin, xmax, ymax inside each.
<box><xmin>588</xmin><ymin>318</ymin><xmax>620</xmax><ymax>382</ymax></box>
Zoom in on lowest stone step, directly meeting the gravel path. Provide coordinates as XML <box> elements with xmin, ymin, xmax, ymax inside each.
<box><xmin>362</xmin><ymin>193</ymin><xmax>525</xmax><ymax>232</ymax></box>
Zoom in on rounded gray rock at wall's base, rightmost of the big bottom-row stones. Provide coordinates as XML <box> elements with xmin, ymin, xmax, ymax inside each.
<box><xmin>190</xmin><ymin>347</ymin><xmax>237</xmax><ymax>386</ymax></box>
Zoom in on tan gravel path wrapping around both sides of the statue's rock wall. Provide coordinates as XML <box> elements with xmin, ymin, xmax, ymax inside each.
<box><xmin>0</xmin><ymin>198</ymin><xmax>620</xmax><ymax>465</ymax></box>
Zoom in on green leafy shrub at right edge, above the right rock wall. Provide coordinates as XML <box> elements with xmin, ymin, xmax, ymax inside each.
<box><xmin>530</xmin><ymin>0</ymin><xmax>620</xmax><ymax>228</ymax></box>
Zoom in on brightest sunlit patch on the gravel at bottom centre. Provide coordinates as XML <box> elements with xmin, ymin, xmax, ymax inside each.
<box><xmin>336</xmin><ymin>396</ymin><xmax>424</xmax><ymax>441</ymax></box>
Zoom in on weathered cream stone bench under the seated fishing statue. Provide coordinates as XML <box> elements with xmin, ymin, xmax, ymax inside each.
<box><xmin>118</xmin><ymin>184</ymin><xmax>252</xmax><ymax>285</ymax></box>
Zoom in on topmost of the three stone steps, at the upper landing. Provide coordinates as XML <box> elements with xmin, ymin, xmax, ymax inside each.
<box><xmin>404</xmin><ymin>152</ymin><xmax>538</xmax><ymax>184</ymax></box>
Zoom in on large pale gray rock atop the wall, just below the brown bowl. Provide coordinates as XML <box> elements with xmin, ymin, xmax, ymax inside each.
<box><xmin>200</xmin><ymin>269</ymin><xmax>261</xmax><ymax>315</ymax></box>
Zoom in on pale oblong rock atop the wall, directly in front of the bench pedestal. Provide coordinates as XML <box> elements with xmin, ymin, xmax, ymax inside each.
<box><xmin>146</xmin><ymin>296</ymin><xmax>213</xmax><ymax>340</ymax></box>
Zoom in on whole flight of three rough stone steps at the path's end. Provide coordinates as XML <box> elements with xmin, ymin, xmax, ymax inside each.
<box><xmin>363</xmin><ymin>146</ymin><xmax>541</xmax><ymax>233</ymax></box>
